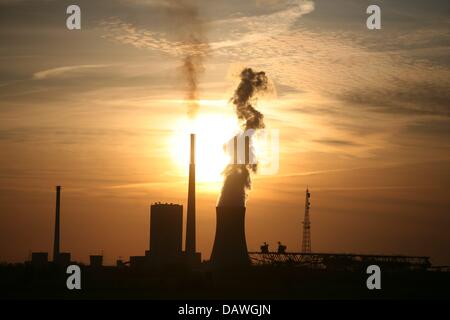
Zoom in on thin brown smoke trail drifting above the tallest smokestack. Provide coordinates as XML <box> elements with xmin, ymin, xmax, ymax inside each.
<box><xmin>169</xmin><ymin>0</ymin><xmax>209</xmax><ymax>118</ymax></box>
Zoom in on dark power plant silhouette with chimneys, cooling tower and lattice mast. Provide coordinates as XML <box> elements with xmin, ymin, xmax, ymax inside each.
<box><xmin>23</xmin><ymin>134</ymin><xmax>431</xmax><ymax>269</ymax></box>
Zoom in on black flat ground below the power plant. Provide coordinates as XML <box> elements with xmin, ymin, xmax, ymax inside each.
<box><xmin>0</xmin><ymin>264</ymin><xmax>450</xmax><ymax>300</ymax></box>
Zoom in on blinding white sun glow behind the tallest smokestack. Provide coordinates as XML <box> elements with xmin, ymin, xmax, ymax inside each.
<box><xmin>170</xmin><ymin>112</ymin><xmax>239</xmax><ymax>183</ymax></box>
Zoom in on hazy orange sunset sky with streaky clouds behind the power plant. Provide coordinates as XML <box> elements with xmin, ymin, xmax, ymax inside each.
<box><xmin>0</xmin><ymin>0</ymin><xmax>450</xmax><ymax>265</ymax></box>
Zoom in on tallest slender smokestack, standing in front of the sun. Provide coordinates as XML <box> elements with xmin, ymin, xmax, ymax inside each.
<box><xmin>186</xmin><ymin>133</ymin><xmax>196</xmax><ymax>254</ymax></box>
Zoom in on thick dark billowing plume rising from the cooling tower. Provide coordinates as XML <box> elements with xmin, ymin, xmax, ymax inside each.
<box><xmin>218</xmin><ymin>68</ymin><xmax>268</xmax><ymax>207</ymax></box>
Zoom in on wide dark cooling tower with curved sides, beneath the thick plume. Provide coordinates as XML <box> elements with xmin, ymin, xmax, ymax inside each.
<box><xmin>211</xmin><ymin>207</ymin><xmax>250</xmax><ymax>268</ymax></box>
